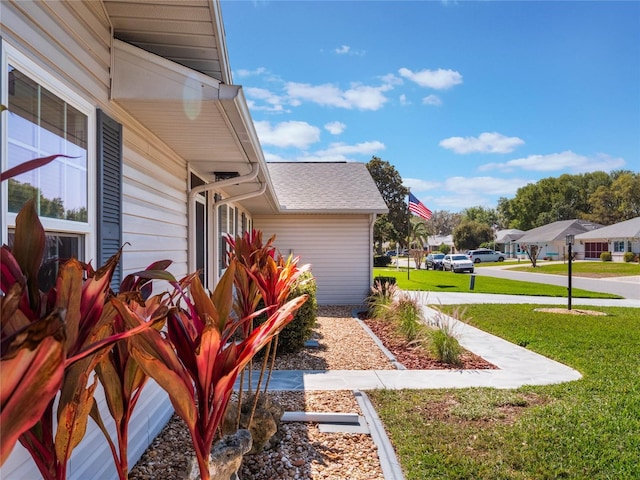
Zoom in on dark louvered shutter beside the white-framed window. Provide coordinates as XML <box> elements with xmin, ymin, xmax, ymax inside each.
<box><xmin>96</xmin><ymin>110</ymin><xmax>122</xmax><ymax>292</ymax></box>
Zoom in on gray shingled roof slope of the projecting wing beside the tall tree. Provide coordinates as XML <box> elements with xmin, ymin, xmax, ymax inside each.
<box><xmin>267</xmin><ymin>162</ymin><xmax>388</xmax><ymax>214</ymax></box>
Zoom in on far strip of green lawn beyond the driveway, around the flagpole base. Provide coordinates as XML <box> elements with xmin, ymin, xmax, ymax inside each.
<box><xmin>373</xmin><ymin>267</ymin><xmax>621</xmax><ymax>298</ymax></box>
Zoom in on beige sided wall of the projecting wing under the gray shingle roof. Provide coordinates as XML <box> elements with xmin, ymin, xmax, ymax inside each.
<box><xmin>254</xmin><ymin>215</ymin><xmax>372</xmax><ymax>305</ymax></box>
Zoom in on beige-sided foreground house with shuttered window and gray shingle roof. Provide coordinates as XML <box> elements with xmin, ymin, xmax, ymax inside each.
<box><xmin>0</xmin><ymin>0</ymin><xmax>386</xmax><ymax>479</ymax></box>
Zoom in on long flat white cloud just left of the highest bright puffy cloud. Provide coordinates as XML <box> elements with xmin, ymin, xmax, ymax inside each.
<box><xmin>285</xmin><ymin>82</ymin><xmax>392</xmax><ymax>110</ymax></box>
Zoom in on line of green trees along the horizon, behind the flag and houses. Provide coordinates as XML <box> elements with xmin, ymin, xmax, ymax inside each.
<box><xmin>367</xmin><ymin>156</ymin><xmax>640</xmax><ymax>253</ymax></box>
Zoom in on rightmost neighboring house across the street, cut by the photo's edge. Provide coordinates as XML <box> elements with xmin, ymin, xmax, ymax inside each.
<box><xmin>575</xmin><ymin>217</ymin><xmax>640</xmax><ymax>262</ymax></box>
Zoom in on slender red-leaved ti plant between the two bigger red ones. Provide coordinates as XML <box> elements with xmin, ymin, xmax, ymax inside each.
<box><xmin>91</xmin><ymin>260</ymin><xmax>177</xmax><ymax>480</ymax></box>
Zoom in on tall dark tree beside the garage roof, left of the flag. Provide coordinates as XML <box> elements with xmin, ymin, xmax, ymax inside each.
<box><xmin>367</xmin><ymin>157</ymin><xmax>409</xmax><ymax>253</ymax></box>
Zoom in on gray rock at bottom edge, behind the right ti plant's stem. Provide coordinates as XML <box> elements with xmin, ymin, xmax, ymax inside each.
<box><xmin>186</xmin><ymin>429</ymin><xmax>252</xmax><ymax>480</ymax></box>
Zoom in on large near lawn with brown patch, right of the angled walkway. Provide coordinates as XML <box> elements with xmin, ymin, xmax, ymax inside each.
<box><xmin>369</xmin><ymin>305</ymin><xmax>640</xmax><ymax>480</ymax></box>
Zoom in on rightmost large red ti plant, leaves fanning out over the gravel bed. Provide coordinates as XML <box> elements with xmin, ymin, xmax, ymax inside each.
<box><xmin>124</xmin><ymin>260</ymin><xmax>306</xmax><ymax>480</ymax></box>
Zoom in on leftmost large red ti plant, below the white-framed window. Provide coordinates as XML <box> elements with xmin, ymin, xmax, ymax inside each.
<box><xmin>0</xmin><ymin>201</ymin><xmax>158</xmax><ymax>480</ymax></box>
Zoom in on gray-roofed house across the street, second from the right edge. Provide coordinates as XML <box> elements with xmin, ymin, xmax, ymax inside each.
<box><xmin>518</xmin><ymin>220</ymin><xmax>602</xmax><ymax>260</ymax></box>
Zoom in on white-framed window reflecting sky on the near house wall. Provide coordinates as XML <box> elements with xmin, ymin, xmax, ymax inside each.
<box><xmin>0</xmin><ymin>42</ymin><xmax>96</xmax><ymax>261</ymax></box>
